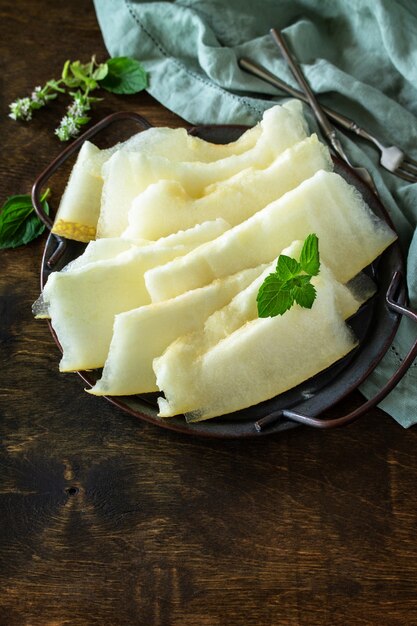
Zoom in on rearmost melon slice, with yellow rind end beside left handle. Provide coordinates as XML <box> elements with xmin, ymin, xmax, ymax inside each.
<box><xmin>52</xmin><ymin>119</ymin><xmax>261</xmax><ymax>242</ymax></box>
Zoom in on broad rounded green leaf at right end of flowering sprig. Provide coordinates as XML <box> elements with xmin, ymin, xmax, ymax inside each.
<box><xmin>99</xmin><ymin>57</ymin><xmax>148</xmax><ymax>94</ymax></box>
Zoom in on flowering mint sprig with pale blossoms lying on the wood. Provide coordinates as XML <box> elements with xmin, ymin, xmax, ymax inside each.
<box><xmin>9</xmin><ymin>55</ymin><xmax>147</xmax><ymax>141</ymax></box>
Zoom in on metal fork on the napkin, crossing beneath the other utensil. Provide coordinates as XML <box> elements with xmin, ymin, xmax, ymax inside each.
<box><xmin>238</xmin><ymin>58</ymin><xmax>417</xmax><ymax>183</ymax></box>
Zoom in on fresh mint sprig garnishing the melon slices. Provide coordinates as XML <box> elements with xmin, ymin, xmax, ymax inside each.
<box><xmin>256</xmin><ymin>233</ymin><xmax>320</xmax><ymax>317</ymax></box>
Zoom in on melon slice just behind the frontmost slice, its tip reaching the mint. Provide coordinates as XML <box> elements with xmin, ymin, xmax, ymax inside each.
<box><xmin>90</xmin><ymin>265</ymin><xmax>264</xmax><ymax>395</ymax></box>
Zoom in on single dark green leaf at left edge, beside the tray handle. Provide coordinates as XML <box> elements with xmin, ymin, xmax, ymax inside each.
<box><xmin>0</xmin><ymin>190</ymin><xmax>49</xmax><ymax>250</ymax></box>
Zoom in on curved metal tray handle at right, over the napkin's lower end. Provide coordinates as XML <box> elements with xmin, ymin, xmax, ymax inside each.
<box><xmin>255</xmin><ymin>272</ymin><xmax>417</xmax><ymax>432</ymax></box>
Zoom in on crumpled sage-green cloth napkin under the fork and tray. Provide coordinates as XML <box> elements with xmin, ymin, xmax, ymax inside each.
<box><xmin>95</xmin><ymin>0</ymin><xmax>417</xmax><ymax>427</ymax></box>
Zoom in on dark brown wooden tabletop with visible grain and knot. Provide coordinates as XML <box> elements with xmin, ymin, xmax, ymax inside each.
<box><xmin>0</xmin><ymin>0</ymin><xmax>417</xmax><ymax>626</ymax></box>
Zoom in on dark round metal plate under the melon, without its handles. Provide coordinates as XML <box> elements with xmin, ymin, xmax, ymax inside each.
<box><xmin>41</xmin><ymin>126</ymin><xmax>406</xmax><ymax>438</ymax></box>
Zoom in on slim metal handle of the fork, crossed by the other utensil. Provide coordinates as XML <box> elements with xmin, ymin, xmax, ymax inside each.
<box><xmin>238</xmin><ymin>57</ymin><xmax>373</xmax><ymax>141</ymax></box>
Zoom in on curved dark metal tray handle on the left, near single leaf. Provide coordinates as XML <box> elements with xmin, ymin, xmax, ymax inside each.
<box><xmin>32</xmin><ymin>111</ymin><xmax>152</xmax><ymax>267</ymax></box>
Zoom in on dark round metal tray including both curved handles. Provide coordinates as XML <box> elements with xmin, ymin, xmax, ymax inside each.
<box><xmin>32</xmin><ymin>112</ymin><xmax>417</xmax><ymax>438</ymax></box>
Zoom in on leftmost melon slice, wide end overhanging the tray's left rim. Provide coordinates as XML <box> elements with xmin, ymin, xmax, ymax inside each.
<box><xmin>39</xmin><ymin>220</ymin><xmax>231</xmax><ymax>371</ymax></box>
